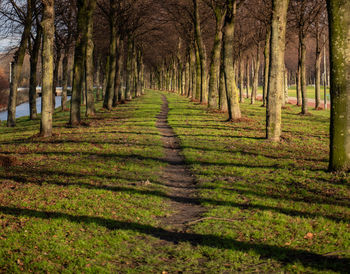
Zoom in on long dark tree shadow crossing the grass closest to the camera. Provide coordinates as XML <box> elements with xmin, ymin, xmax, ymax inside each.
<box><xmin>0</xmin><ymin>206</ymin><xmax>350</xmax><ymax>273</ymax></box>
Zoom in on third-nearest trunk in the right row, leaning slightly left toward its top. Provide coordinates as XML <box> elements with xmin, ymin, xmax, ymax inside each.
<box><xmin>223</xmin><ymin>0</ymin><xmax>241</xmax><ymax>120</ymax></box>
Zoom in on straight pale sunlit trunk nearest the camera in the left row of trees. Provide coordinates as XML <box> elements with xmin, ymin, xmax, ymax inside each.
<box><xmin>40</xmin><ymin>0</ymin><xmax>55</xmax><ymax>137</ymax></box>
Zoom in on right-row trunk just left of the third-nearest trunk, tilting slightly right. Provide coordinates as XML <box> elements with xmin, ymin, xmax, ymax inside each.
<box><xmin>208</xmin><ymin>6</ymin><xmax>225</xmax><ymax>109</ymax></box>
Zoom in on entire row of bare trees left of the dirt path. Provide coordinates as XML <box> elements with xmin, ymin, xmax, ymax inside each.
<box><xmin>0</xmin><ymin>0</ymin><xmax>149</xmax><ymax>132</ymax></box>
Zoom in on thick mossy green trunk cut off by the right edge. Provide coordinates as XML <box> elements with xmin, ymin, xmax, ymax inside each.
<box><xmin>327</xmin><ymin>0</ymin><xmax>350</xmax><ymax>171</ymax></box>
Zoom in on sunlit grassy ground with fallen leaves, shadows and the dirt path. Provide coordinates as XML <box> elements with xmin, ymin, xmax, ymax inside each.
<box><xmin>0</xmin><ymin>91</ymin><xmax>350</xmax><ymax>273</ymax></box>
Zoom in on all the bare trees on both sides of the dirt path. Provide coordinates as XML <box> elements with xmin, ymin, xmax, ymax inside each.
<box><xmin>0</xmin><ymin>0</ymin><xmax>350</xmax><ymax>170</ymax></box>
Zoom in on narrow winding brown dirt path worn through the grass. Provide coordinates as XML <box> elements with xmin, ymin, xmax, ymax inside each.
<box><xmin>157</xmin><ymin>95</ymin><xmax>205</xmax><ymax>232</ymax></box>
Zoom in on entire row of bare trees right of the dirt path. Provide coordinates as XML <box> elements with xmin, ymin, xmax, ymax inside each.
<box><xmin>145</xmin><ymin>0</ymin><xmax>350</xmax><ymax>170</ymax></box>
